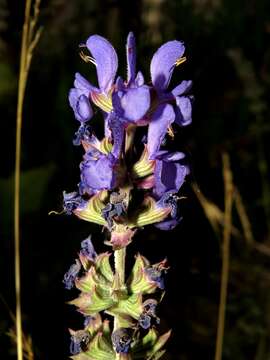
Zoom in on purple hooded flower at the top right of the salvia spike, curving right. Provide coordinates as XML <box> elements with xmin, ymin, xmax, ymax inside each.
<box><xmin>148</xmin><ymin>40</ymin><xmax>192</xmax><ymax>159</ymax></box>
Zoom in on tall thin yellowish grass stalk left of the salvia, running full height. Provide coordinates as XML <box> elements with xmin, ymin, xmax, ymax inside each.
<box><xmin>14</xmin><ymin>0</ymin><xmax>41</xmax><ymax>360</ymax></box>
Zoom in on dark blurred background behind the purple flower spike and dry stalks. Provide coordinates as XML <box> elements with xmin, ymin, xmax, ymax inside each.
<box><xmin>0</xmin><ymin>0</ymin><xmax>270</xmax><ymax>360</ymax></box>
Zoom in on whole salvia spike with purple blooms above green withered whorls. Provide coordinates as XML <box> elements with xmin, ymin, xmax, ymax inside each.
<box><xmin>63</xmin><ymin>33</ymin><xmax>192</xmax><ymax>360</ymax></box>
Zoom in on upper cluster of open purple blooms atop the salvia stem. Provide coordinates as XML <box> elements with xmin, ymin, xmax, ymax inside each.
<box><xmin>64</xmin><ymin>33</ymin><xmax>192</xmax><ymax>248</ymax></box>
